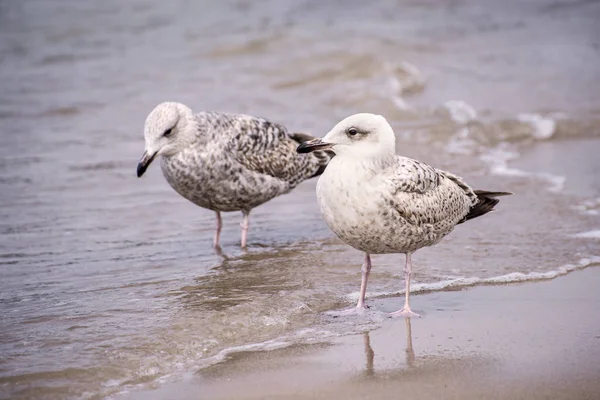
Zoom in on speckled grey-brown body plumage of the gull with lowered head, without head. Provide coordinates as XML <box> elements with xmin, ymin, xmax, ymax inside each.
<box><xmin>161</xmin><ymin>112</ymin><xmax>327</xmax><ymax>211</ymax></box>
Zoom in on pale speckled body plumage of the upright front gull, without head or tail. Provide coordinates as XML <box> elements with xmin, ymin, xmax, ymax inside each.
<box><xmin>317</xmin><ymin>155</ymin><xmax>477</xmax><ymax>254</ymax></box>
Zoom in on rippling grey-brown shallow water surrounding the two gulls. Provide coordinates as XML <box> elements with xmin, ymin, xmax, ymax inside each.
<box><xmin>0</xmin><ymin>0</ymin><xmax>600</xmax><ymax>399</ymax></box>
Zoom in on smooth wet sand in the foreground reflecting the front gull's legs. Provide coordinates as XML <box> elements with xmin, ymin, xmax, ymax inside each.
<box><xmin>125</xmin><ymin>268</ymin><xmax>600</xmax><ymax>400</ymax></box>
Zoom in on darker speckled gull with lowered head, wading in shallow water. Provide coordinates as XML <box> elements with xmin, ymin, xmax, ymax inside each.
<box><xmin>137</xmin><ymin>102</ymin><xmax>333</xmax><ymax>248</ymax></box>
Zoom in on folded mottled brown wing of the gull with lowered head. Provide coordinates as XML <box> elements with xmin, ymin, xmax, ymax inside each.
<box><xmin>220</xmin><ymin>115</ymin><xmax>320</xmax><ymax>185</ymax></box>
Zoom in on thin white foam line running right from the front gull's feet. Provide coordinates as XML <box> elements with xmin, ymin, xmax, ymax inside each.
<box><xmin>346</xmin><ymin>258</ymin><xmax>600</xmax><ymax>301</ymax></box>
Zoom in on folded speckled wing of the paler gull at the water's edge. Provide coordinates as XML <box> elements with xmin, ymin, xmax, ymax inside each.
<box><xmin>388</xmin><ymin>157</ymin><xmax>477</xmax><ymax>227</ymax></box>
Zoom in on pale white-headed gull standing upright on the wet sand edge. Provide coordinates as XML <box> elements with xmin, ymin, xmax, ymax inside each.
<box><xmin>297</xmin><ymin>113</ymin><xmax>512</xmax><ymax>317</ymax></box>
